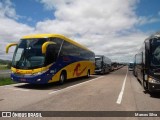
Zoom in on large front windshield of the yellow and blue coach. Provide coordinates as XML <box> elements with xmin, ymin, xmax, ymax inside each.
<box><xmin>12</xmin><ymin>38</ymin><xmax>47</xmax><ymax>69</ymax></box>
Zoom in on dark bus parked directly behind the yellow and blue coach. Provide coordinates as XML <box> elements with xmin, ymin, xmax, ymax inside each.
<box><xmin>95</xmin><ymin>55</ymin><xmax>111</xmax><ymax>74</ymax></box>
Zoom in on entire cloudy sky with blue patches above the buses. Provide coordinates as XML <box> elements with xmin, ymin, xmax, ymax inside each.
<box><xmin>0</xmin><ymin>0</ymin><xmax>160</xmax><ymax>62</ymax></box>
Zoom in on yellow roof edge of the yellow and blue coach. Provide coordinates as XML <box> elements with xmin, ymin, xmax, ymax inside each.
<box><xmin>22</xmin><ymin>34</ymin><xmax>92</xmax><ymax>52</ymax></box>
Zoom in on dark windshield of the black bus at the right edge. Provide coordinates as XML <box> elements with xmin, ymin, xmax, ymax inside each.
<box><xmin>151</xmin><ymin>39</ymin><xmax>160</xmax><ymax>69</ymax></box>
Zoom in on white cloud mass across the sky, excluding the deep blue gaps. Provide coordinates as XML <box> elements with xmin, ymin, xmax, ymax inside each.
<box><xmin>0</xmin><ymin>0</ymin><xmax>156</xmax><ymax>61</ymax></box>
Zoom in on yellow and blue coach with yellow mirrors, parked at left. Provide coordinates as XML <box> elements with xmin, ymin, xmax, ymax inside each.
<box><xmin>6</xmin><ymin>34</ymin><xmax>95</xmax><ymax>84</ymax></box>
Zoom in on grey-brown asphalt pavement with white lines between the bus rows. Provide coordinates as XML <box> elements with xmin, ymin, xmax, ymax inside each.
<box><xmin>0</xmin><ymin>67</ymin><xmax>160</xmax><ymax>120</ymax></box>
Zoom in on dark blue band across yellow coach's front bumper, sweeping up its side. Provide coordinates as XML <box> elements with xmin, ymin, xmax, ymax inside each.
<box><xmin>11</xmin><ymin>56</ymin><xmax>85</xmax><ymax>84</ymax></box>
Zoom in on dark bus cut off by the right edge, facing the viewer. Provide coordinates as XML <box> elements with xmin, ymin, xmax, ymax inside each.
<box><xmin>134</xmin><ymin>33</ymin><xmax>160</xmax><ymax>92</ymax></box>
